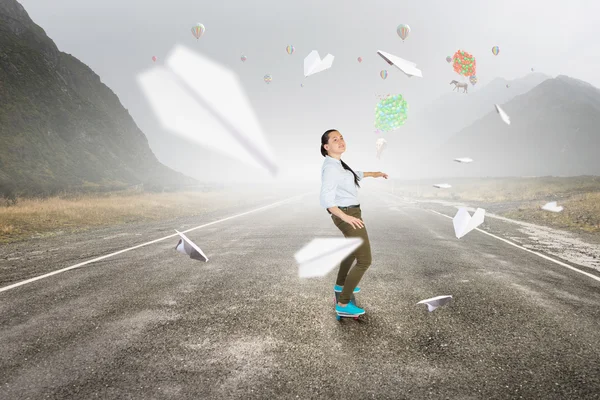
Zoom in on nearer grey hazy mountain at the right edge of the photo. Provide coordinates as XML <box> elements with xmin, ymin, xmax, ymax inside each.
<box><xmin>423</xmin><ymin>75</ymin><xmax>600</xmax><ymax>177</ymax></box>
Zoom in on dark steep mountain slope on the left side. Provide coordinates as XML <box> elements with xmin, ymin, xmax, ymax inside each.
<box><xmin>0</xmin><ymin>0</ymin><xmax>196</xmax><ymax>195</ymax></box>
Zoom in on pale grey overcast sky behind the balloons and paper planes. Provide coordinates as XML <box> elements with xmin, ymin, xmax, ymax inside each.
<box><xmin>20</xmin><ymin>0</ymin><xmax>600</xmax><ymax>182</ymax></box>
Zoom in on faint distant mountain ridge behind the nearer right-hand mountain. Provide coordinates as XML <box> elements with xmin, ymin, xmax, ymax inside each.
<box><xmin>386</xmin><ymin>73</ymin><xmax>550</xmax><ymax>179</ymax></box>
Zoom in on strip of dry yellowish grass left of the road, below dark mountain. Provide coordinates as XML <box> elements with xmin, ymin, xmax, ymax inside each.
<box><xmin>0</xmin><ymin>191</ymin><xmax>264</xmax><ymax>243</ymax></box>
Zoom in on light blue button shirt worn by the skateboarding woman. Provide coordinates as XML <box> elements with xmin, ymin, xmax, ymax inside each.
<box><xmin>321</xmin><ymin>156</ymin><xmax>364</xmax><ymax>208</ymax></box>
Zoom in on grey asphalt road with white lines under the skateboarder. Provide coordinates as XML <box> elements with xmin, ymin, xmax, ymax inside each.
<box><xmin>0</xmin><ymin>191</ymin><xmax>600</xmax><ymax>399</ymax></box>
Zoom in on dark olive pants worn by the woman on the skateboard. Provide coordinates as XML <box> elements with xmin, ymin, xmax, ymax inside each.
<box><xmin>331</xmin><ymin>207</ymin><xmax>371</xmax><ymax>304</ymax></box>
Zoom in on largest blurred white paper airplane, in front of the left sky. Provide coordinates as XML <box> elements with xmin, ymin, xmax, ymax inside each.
<box><xmin>137</xmin><ymin>46</ymin><xmax>278</xmax><ymax>175</ymax></box>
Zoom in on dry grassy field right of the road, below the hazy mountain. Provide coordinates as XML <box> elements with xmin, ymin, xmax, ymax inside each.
<box><xmin>394</xmin><ymin>176</ymin><xmax>600</xmax><ymax>233</ymax></box>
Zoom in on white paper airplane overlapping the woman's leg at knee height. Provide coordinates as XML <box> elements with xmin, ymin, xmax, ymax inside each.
<box><xmin>294</xmin><ymin>238</ymin><xmax>363</xmax><ymax>278</ymax></box>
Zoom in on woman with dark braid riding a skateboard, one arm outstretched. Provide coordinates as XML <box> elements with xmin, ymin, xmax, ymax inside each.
<box><xmin>321</xmin><ymin>129</ymin><xmax>388</xmax><ymax>315</ymax></box>
